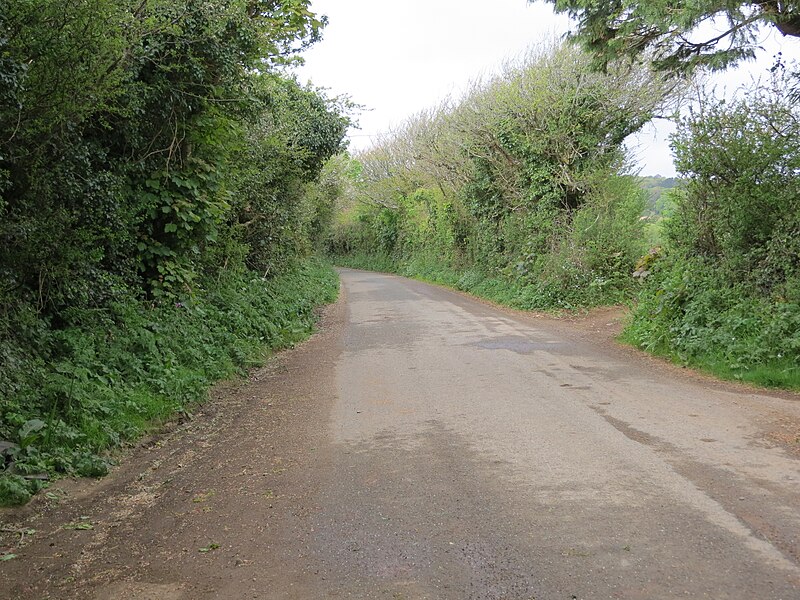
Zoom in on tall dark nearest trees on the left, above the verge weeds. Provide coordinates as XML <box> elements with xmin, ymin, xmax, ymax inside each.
<box><xmin>0</xmin><ymin>0</ymin><xmax>332</xmax><ymax>304</ymax></box>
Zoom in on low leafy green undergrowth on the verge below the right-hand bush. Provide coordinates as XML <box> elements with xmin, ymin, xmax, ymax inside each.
<box><xmin>620</xmin><ymin>258</ymin><xmax>800</xmax><ymax>390</ymax></box>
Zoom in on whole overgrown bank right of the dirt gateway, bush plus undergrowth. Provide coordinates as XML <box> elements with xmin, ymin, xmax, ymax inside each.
<box><xmin>625</xmin><ymin>74</ymin><xmax>800</xmax><ymax>389</ymax></box>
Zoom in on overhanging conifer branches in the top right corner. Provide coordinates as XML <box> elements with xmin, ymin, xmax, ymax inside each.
<box><xmin>547</xmin><ymin>0</ymin><xmax>800</xmax><ymax>73</ymax></box>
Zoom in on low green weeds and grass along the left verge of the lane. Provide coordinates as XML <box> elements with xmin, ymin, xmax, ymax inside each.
<box><xmin>0</xmin><ymin>259</ymin><xmax>338</xmax><ymax>506</ymax></box>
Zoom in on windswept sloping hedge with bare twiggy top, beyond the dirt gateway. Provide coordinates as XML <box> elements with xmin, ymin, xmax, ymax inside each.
<box><xmin>329</xmin><ymin>44</ymin><xmax>680</xmax><ymax>309</ymax></box>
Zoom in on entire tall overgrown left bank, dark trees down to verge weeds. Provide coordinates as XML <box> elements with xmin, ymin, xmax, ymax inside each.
<box><xmin>0</xmin><ymin>0</ymin><xmax>350</xmax><ymax>503</ymax></box>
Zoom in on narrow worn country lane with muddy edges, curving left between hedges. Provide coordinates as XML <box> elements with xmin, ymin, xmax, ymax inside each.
<box><xmin>0</xmin><ymin>270</ymin><xmax>800</xmax><ymax>600</ymax></box>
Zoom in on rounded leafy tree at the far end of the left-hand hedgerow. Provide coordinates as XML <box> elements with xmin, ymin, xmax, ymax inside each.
<box><xmin>225</xmin><ymin>76</ymin><xmax>350</xmax><ymax>273</ymax></box>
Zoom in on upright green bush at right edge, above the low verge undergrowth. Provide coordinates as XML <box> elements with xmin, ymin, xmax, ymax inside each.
<box><xmin>669</xmin><ymin>70</ymin><xmax>800</xmax><ymax>274</ymax></box>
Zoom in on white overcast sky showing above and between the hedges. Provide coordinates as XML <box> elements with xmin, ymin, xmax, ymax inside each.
<box><xmin>298</xmin><ymin>0</ymin><xmax>800</xmax><ymax>176</ymax></box>
